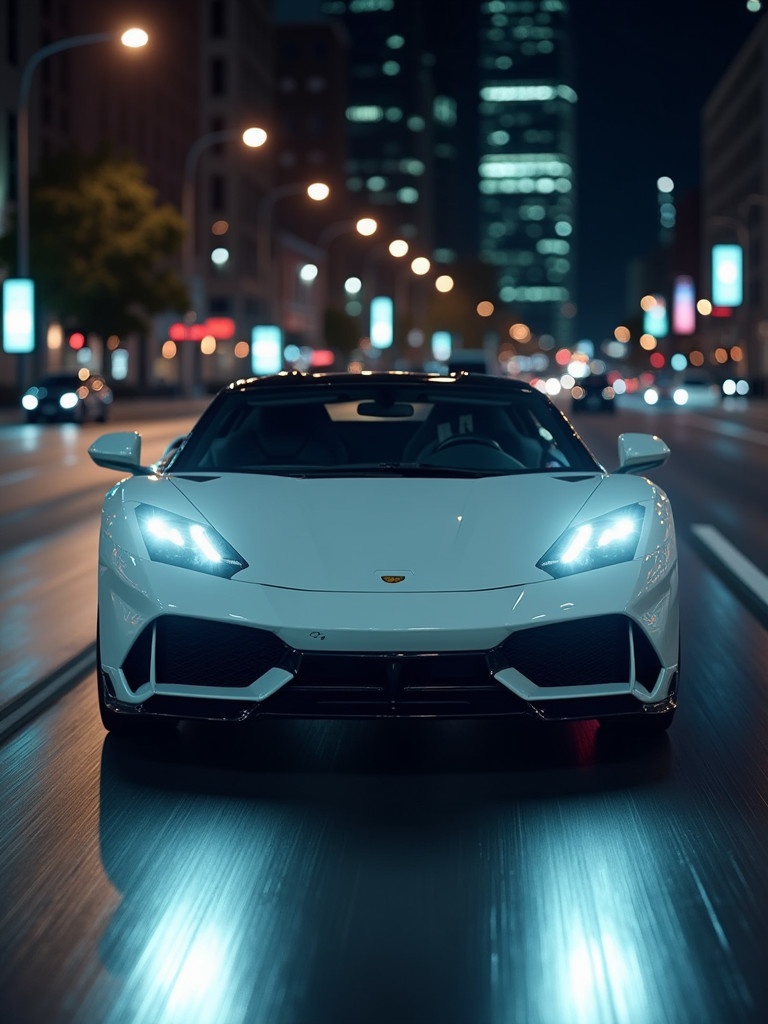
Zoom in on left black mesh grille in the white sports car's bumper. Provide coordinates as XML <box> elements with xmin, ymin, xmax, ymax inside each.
<box><xmin>123</xmin><ymin>615</ymin><xmax>288</xmax><ymax>690</ymax></box>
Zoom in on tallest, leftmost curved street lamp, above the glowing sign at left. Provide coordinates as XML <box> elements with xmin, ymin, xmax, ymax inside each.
<box><xmin>16</xmin><ymin>29</ymin><xmax>150</xmax><ymax>278</ymax></box>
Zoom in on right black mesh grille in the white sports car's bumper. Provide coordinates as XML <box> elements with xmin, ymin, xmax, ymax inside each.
<box><xmin>495</xmin><ymin>615</ymin><xmax>634</xmax><ymax>686</ymax></box>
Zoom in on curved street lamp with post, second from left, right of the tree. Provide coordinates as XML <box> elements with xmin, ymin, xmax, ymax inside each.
<box><xmin>181</xmin><ymin>127</ymin><xmax>267</xmax><ymax>394</ymax></box>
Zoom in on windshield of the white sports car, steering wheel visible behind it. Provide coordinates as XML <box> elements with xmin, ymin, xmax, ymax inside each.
<box><xmin>168</xmin><ymin>376</ymin><xmax>601</xmax><ymax>476</ymax></box>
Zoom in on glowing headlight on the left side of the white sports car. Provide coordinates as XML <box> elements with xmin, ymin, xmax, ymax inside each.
<box><xmin>136</xmin><ymin>505</ymin><xmax>248</xmax><ymax>580</ymax></box>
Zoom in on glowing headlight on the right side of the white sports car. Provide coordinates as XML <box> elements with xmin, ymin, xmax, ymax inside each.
<box><xmin>536</xmin><ymin>505</ymin><xmax>644</xmax><ymax>580</ymax></box>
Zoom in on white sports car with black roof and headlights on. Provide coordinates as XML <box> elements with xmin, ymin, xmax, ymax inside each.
<box><xmin>89</xmin><ymin>372</ymin><xmax>679</xmax><ymax>732</ymax></box>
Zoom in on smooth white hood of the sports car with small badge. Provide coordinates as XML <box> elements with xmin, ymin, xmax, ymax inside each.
<box><xmin>165</xmin><ymin>473</ymin><xmax>638</xmax><ymax>592</ymax></box>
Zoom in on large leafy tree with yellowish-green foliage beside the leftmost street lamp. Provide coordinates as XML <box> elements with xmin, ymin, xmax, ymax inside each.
<box><xmin>0</xmin><ymin>151</ymin><xmax>188</xmax><ymax>337</ymax></box>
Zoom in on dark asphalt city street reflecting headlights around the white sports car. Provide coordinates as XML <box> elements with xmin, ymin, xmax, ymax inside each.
<box><xmin>0</xmin><ymin>404</ymin><xmax>768</xmax><ymax>1024</ymax></box>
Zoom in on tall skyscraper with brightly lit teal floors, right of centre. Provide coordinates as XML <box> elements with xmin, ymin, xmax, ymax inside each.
<box><xmin>477</xmin><ymin>0</ymin><xmax>577</xmax><ymax>344</ymax></box>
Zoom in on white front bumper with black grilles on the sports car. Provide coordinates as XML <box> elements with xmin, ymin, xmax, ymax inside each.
<box><xmin>99</xmin><ymin>559</ymin><xmax>679</xmax><ymax>720</ymax></box>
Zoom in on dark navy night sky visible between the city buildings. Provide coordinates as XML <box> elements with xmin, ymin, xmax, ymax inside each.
<box><xmin>273</xmin><ymin>0</ymin><xmax>765</xmax><ymax>341</ymax></box>
